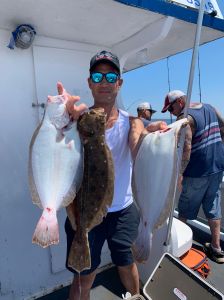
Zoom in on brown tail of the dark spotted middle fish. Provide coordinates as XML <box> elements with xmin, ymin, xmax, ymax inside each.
<box><xmin>68</xmin><ymin>232</ymin><xmax>91</xmax><ymax>273</ymax></box>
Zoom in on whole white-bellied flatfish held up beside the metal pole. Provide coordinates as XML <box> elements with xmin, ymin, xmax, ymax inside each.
<box><xmin>132</xmin><ymin>119</ymin><xmax>188</xmax><ymax>262</ymax></box>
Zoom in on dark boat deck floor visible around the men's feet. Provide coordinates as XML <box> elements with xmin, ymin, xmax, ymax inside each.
<box><xmin>39</xmin><ymin>228</ymin><xmax>224</xmax><ymax>300</ymax></box>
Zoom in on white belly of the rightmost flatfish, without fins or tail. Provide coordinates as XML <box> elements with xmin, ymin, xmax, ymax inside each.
<box><xmin>134</xmin><ymin>131</ymin><xmax>176</xmax><ymax>230</ymax></box>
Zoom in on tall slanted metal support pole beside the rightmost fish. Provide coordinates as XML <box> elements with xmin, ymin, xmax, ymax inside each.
<box><xmin>164</xmin><ymin>0</ymin><xmax>205</xmax><ymax>247</ymax></box>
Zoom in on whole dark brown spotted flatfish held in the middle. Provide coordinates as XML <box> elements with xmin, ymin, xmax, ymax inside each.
<box><xmin>67</xmin><ymin>108</ymin><xmax>114</xmax><ymax>272</ymax></box>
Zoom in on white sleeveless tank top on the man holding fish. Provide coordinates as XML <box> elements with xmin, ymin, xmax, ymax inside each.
<box><xmin>106</xmin><ymin>110</ymin><xmax>133</xmax><ymax>212</ymax></box>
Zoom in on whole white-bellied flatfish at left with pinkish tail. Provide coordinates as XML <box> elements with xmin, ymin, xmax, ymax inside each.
<box><xmin>29</xmin><ymin>95</ymin><xmax>83</xmax><ymax>247</ymax></box>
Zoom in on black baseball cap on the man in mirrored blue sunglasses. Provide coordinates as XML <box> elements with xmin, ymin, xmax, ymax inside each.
<box><xmin>89</xmin><ymin>50</ymin><xmax>121</xmax><ymax>74</ymax></box>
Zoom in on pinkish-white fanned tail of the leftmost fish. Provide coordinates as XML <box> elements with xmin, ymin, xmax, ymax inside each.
<box><xmin>32</xmin><ymin>207</ymin><xmax>59</xmax><ymax>248</ymax></box>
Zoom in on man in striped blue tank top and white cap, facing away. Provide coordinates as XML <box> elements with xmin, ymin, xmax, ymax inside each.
<box><xmin>162</xmin><ymin>90</ymin><xmax>224</xmax><ymax>263</ymax></box>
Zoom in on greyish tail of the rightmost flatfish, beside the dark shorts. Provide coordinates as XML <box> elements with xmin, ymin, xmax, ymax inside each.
<box><xmin>132</xmin><ymin>220</ymin><xmax>152</xmax><ymax>263</ymax></box>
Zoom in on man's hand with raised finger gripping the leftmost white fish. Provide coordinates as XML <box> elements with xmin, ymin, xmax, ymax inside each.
<box><xmin>57</xmin><ymin>82</ymin><xmax>88</xmax><ymax>120</ymax></box>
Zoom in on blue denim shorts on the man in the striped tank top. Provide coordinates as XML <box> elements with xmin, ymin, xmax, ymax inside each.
<box><xmin>178</xmin><ymin>172</ymin><xmax>223</xmax><ymax>220</ymax></box>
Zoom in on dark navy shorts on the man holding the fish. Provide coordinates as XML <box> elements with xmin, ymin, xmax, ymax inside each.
<box><xmin>65</xmin><ymin>203</ymin><xmax>139</xmax><ymax>275</ymax></box>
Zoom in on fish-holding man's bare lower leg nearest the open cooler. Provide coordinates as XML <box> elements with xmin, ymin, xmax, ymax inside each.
<box><xmin>118</xmin><ymin>263</ymin><xmax>139</xmax><ymax>295</ymax></box>
